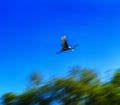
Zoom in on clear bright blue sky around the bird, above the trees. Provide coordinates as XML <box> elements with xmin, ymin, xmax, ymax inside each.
<box><xmin>0</xmin><ymin>0</ymin><xmax>120</xmax><ymax>94</ymax></box>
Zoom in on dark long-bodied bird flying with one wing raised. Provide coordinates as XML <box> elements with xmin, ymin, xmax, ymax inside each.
<box><xmin>56</xmin><ymin>36</ymin><xmax>79</xmax><ymax>54</ymax></box>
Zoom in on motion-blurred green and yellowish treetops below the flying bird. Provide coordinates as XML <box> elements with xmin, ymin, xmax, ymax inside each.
<box><xmin>2</xmin><ymin>67</ymin><xmax>120</xmax><ymax>105</ymax></box>
